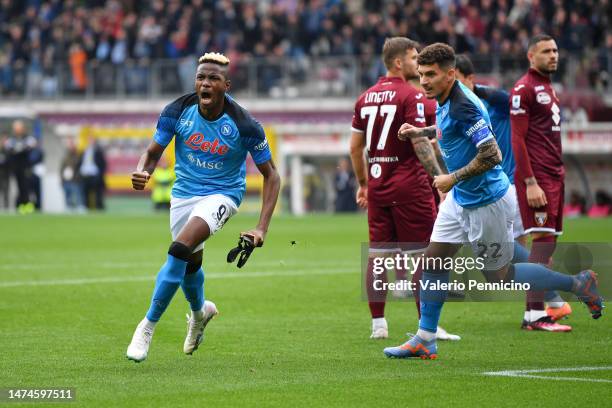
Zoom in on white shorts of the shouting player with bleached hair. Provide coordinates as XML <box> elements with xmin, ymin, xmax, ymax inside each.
<box><xmin>170</xmin><ymin>194</ymin><xmax>238</xmax><ymax>252</ymax></box>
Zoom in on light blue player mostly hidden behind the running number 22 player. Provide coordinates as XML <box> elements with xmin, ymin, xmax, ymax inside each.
<box><xmin>455</xmin><ymin>55</ymin><xmax>572</xmax><ymax>332</ymax></box>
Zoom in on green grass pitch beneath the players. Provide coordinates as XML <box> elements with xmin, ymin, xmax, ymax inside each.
<box><xmin>0</xmin><ymin>214</ymin><xmax>612</xmax><ymax>407</ymax></box>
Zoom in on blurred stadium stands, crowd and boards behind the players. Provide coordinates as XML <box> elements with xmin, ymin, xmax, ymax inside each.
<box><xmin>0</xmin><ymin>0</ymin><xmax>612</xmax><ymax>217</ymax></box>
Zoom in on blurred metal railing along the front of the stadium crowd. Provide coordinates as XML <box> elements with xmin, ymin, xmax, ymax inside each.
<box><xmin>0</xmin><ymin>53</ymin><xmax>612</xmax><ymax>99</ymax></box>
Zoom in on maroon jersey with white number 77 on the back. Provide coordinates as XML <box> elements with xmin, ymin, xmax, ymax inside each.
<box><xmin>352</xmin><ymin>77</ymin><xmax>431</xmax><ymax>206</ymax></box>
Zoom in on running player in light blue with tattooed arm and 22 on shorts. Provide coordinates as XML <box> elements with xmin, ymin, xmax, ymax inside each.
<box><xmin>384</xmin><ymin>43</ymin><xmax>603</xmax><ymax>359</ymax></box>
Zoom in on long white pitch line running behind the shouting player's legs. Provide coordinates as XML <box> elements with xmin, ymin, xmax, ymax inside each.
<box><xmin>0</xmin><ymin>268</ymin><xmax>359</xmax><ymax>289</ymax></box>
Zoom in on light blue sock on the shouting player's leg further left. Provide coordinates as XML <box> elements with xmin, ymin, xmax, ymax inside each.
<box><xmin>147</xmin><ymin>254</ymin><xmax>187</xmax><ymax>322</ymax></box>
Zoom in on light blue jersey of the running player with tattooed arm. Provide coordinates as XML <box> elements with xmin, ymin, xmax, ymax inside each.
<box><xmin>436</xmin><ymin>81</ymin><xmax>510</xmax><ymax>208</ymax></box>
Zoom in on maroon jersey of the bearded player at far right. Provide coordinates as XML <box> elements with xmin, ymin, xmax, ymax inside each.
<box><xmin>510</xmin><ymin>69</ymin><xmax>565</xmax><ymax>181</ymax></box>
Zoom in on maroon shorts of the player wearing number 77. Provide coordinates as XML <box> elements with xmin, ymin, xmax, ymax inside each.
<box><xmin>368</xmin><ymin>196</ymin><xmax>436</xmax><ymax>251</ymax></box>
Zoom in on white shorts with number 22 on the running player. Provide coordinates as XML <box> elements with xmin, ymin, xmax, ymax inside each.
<box><xmin>431</xmin><ymin>189</ymin><xmax>518</xmax><ymax>271</ymax></box>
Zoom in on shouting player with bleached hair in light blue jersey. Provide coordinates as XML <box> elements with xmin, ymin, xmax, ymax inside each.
<box><xmin>126</xmin><ymin>53</ymin><xmax>280</xmax><ymax>362</ymax></box>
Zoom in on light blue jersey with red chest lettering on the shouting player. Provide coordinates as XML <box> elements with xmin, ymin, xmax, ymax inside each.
<box><xmin>153</xmin><ymin>93</ymin><xmax>272</xmax><ymax>206</ymax></box>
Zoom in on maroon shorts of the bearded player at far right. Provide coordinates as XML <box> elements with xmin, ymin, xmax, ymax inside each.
<box><xmin>516</xmin><ymin>179</ymin><xmax>565</xmax><ymax>235</ymax></box>
